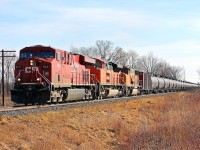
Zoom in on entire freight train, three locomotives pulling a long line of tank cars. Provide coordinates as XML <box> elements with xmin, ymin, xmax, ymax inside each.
<box><xmin>11</xmin><ymin>45</ymin><xmax>198</xmax><ymax>105</ymax></box>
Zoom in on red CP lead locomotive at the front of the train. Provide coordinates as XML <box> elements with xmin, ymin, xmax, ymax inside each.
<box><xmin>11</xmin><ymin>46</ymin><xmax>95</xmax><ymax>105</ymax></box>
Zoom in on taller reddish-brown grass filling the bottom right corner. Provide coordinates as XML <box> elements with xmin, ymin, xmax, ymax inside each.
<box><xmin>124</xmin><ymin>91</ymin><xmax>200</xmax><ymax>150</ymax></box>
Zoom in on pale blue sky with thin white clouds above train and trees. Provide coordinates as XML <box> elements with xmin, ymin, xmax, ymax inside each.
<box><xmin>0</xmin><ymin>0</ymin><xmax>200</xmax><ymax>82</ymax></box>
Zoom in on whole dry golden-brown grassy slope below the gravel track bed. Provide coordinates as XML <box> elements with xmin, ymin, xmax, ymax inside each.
<box><xmin>0</xmin><ymin>91</ymin><xmax>200</xmax><ymax>150</ymax></box>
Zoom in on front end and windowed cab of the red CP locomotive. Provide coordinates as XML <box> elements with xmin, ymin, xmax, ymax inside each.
<box><xmin>11</xmin><ymin>46</ymin><xmax>61</xmax><ymax>105</ymax></box>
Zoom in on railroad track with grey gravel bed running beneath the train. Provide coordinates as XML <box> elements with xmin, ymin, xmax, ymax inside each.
<box><xmin>0</xmin><ymin>92</ymin><xmax>174</xmax><ymax>116</ymax></box>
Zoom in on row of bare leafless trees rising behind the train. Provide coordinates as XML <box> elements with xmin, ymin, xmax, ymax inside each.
<box><xmin>71</xmin><ymin>40</ymin><xmax>185</xmax><ymax>80</ymax></box>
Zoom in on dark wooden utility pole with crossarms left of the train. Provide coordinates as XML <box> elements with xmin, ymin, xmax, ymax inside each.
<box><xmin>0</xmin><ymin>49</ymin><xmax>16</xmax><ymax>106</ymax></box>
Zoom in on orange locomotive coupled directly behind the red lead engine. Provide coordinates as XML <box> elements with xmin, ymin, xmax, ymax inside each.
<box><xmin>90</xmin><ymin>59</ymin><xmax>125</xmax><ymax>98</ymax></box>
